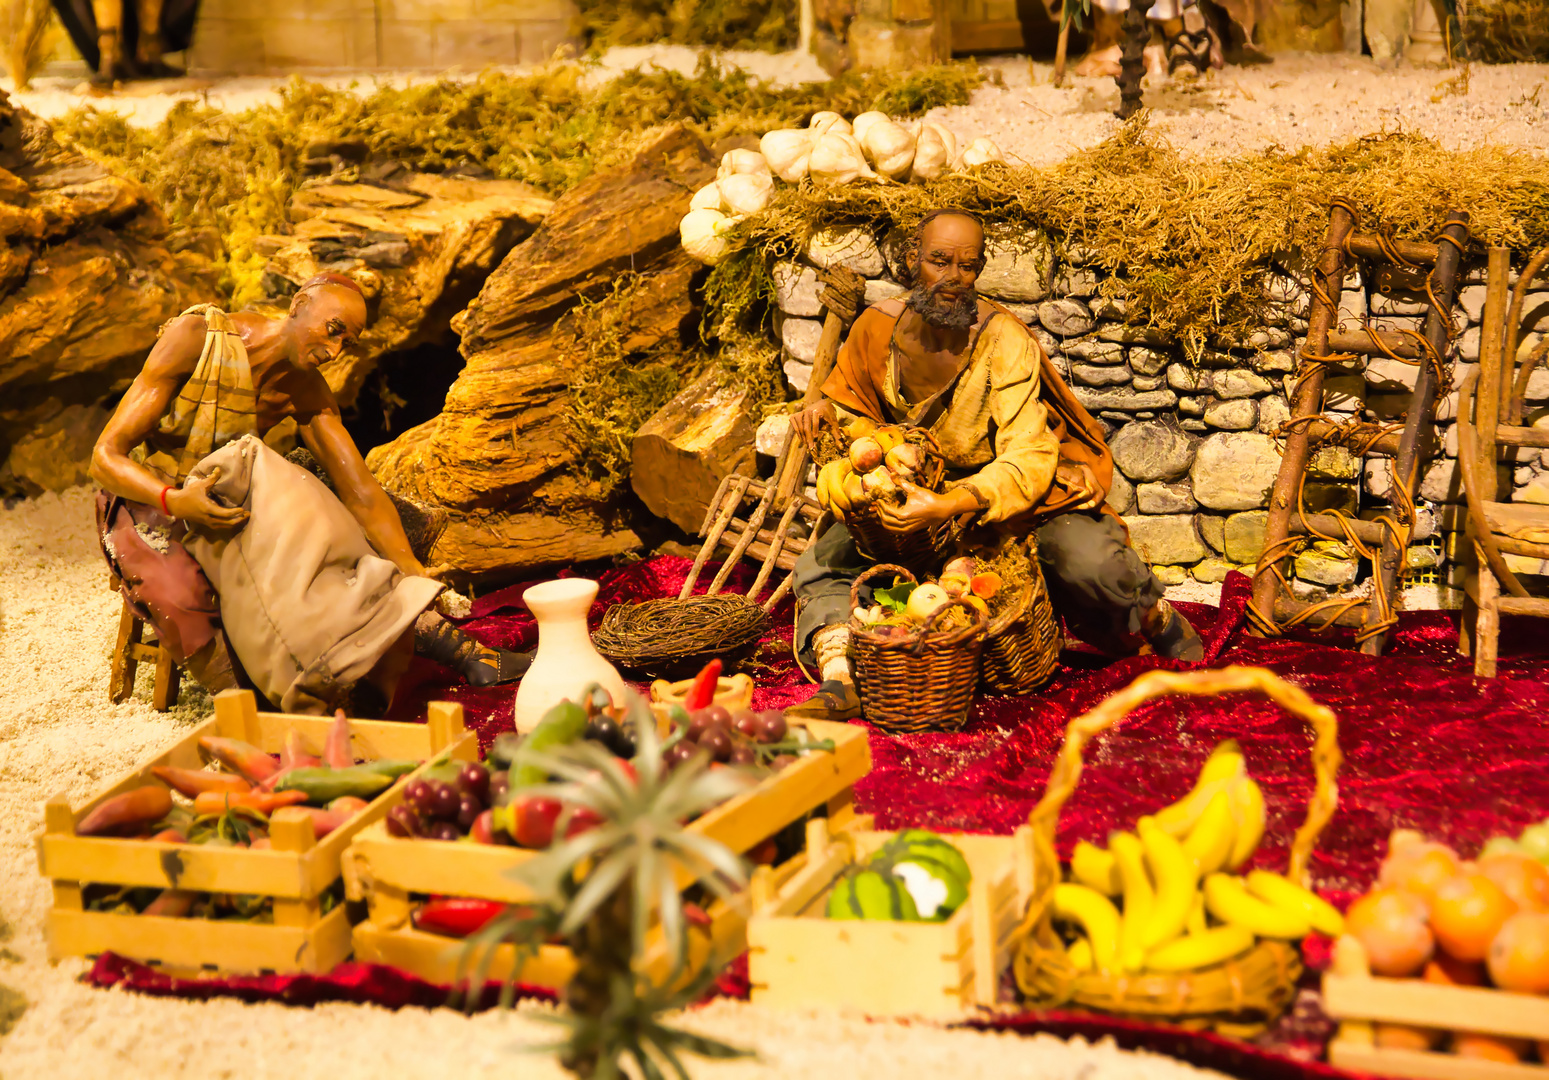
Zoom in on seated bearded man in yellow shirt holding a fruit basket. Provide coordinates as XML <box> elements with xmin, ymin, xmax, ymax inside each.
<box><xmin>787</xmin><ymin>211</ymin><xmax>1204</xmax><ymax>719</ymax></box>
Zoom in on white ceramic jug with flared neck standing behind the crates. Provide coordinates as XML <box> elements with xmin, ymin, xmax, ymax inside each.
<box><xmin>514</xmin><ymin>578</ymin><xmax>624</xmax><ymax>734</ymax></box>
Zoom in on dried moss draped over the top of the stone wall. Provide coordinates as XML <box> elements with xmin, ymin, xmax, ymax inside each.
<box><xmin>742</xmin><ymin>113</ymin><xmax>1549</xmax><ymax>350</ymax></box>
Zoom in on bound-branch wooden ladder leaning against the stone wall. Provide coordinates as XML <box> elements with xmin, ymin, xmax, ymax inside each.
<box><xmin>1248</xmin><ymin>198</ymin><xmax>1468</xmax><ymax>655</ymax></box>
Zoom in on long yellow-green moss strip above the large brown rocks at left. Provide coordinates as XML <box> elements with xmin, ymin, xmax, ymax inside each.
<box><xmin>54</xmin><ymin>57</ymin><xmax>982</xmax><ymax>305</ymax></box>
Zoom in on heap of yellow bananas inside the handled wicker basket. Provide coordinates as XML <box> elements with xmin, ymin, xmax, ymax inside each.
<box><xmin>1052</xmin><ymin>739</ymin><xmax>1345</xmax><ymax>975</ymax></box>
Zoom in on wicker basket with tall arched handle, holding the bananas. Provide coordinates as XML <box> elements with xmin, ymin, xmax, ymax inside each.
<box><xmin>1013</xmin><ymin>666</ymin><xmax>1340</xmax><ymax>1038</ymax></box>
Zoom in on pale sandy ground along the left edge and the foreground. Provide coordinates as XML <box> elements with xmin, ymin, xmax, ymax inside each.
<box><xmin>0</xmin><ymin>488</ymin><xmax>1219</xmax><ymax>1080</ymax></box>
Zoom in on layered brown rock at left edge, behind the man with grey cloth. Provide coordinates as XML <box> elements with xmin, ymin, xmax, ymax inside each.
<box><xmin>0</xmin><ymin>91</ymin><xmax>218</xmax><ymax>494</ymax></box>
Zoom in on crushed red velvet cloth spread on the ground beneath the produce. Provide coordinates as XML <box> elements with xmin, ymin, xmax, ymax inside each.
<box><xmin>87</xmin><ymin>558</ymin><xmax>1549</xmax><ymax>1077</ymax></box>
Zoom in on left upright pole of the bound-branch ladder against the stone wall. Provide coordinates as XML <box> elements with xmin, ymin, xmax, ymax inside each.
<box><xmin>1248</xmin><ymin>203</ymin><xmax>1355</xmax><ymax>634</ymax></box>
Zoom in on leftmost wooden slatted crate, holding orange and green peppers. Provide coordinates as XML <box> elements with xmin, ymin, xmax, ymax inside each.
<box><xmin>37</xmin><ymin>691</ymin><xmax>479</xmax><ymax>973</ymax></box>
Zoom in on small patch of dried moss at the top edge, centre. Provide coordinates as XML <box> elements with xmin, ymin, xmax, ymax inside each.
<box><xmin>576</xmin><ymin>0</ymin><xmax>798</xmax><ymax>53</ymax></box>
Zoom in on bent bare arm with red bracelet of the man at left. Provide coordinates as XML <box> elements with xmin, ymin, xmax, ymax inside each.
<box><xmin>91</xmin><ymin>315</ymin><xmax>248</xmax><ymax>528</ymax></box>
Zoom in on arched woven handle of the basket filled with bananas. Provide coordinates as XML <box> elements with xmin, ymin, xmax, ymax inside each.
<box><xmin>1027</xmin><ymin>665</ymin><xmax>1343</xmax><ymax>906</ymax></box>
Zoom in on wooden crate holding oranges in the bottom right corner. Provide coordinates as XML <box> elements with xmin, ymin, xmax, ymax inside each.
<box><xmin>1323</xmin><ymin>936</ymin><xmax>1549</xmax><ymax>1080</ymax></box>
